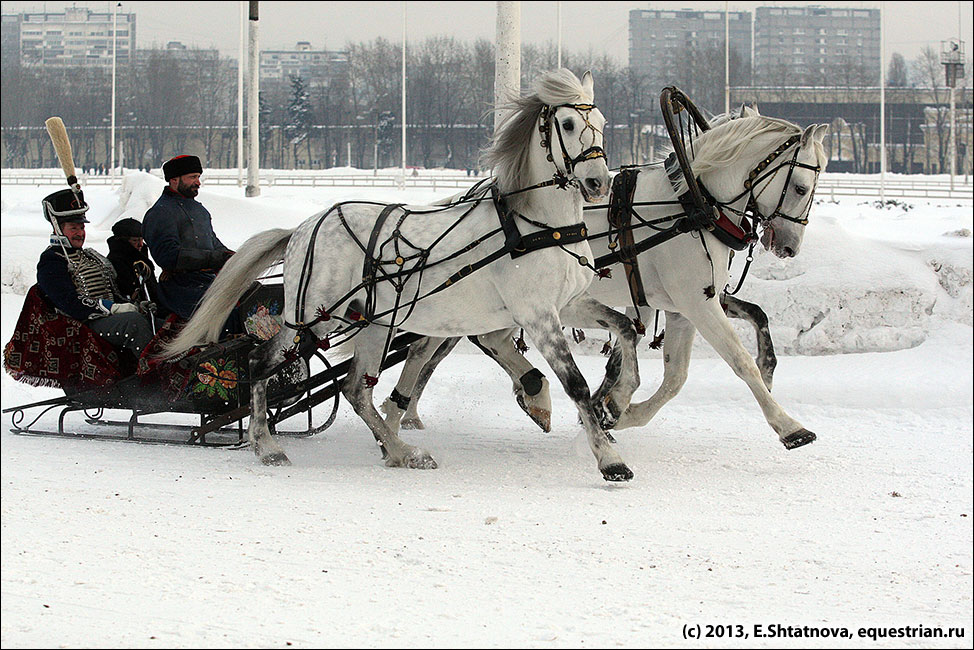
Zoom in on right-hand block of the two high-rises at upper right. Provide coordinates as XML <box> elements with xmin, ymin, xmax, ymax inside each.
<box><xmin>754</xmin><ymin>6</ymin><xmax>880</xmax><ymax>86</ymax></box>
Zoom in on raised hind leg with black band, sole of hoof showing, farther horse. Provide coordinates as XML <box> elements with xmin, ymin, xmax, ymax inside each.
<box><xmin>471</xmin><ymin>330</ymin><xmax>551</xmax><ymax>433</ymax></box>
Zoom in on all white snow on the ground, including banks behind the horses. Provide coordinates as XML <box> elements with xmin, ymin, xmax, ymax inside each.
<box><xmin>0</xmin><ymin>173</ymin><xmax>974</xmax><ymax>648</ymax></box>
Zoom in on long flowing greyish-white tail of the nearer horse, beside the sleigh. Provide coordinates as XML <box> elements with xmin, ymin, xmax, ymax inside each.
<box><xmin>163</xmin><ymin>228</ymin><xmax>294</xmax><ymax>357</ymax></box>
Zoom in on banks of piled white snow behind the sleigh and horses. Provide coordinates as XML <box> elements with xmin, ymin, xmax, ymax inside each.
<box><xmin>2</xmin><ymin>172</ymin><xmax>974</xmax><ymax>355</ymax></box>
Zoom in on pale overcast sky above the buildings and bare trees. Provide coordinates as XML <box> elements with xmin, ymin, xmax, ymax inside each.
<box><xmin>0</xmin><ymin>0</ymin><xmax>974</xmax><ymax>65</ymax></box>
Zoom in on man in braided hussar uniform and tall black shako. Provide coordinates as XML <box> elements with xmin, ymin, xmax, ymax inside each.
<box><xmin>37</xmin><ymin>189</ymin><xmax>152</xmax><ymax>357</ymax></box>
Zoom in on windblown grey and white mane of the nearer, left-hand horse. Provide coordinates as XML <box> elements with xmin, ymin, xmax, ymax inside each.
<box><xmin>481</xmin><ymin>68</ymin><xmax>594</xmax><ymax>197</ymax></box>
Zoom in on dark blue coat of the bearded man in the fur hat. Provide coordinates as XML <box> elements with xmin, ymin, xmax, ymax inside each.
<box><xmin>142</xmin><ymin>187</ymin><xmax>232</xmax><ymax>319</ymax></box>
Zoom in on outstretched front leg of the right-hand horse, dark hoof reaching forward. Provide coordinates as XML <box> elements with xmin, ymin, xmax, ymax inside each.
<box><xmin>680</xmin><ymin>300</ymin><xmax>816</xmax><ymax>449</ymax></box>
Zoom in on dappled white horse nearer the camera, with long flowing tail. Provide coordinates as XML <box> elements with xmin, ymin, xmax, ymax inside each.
<box><xmin>167</xmin><ymin>70</ymin><xmax>638</xmax><ymax>481</ymax></box>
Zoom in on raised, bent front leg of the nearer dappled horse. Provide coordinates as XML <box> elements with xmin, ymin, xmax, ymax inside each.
<box><xmin>561</xmin><ymin>296</ymin><xmax>639</xmax><ymax>428</ymax></box>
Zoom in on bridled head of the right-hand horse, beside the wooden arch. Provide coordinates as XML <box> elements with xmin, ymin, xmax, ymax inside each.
<box><xmin>751</xmin><ymin>124</ymin><xmax>829</xmax><ymax>258</ymax></box>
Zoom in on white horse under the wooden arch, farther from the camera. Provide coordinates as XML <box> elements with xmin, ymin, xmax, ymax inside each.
<box><xmin>383</xmin><ymin>110</ymin><xmax>828</xmax><ymax>449</ymax></box>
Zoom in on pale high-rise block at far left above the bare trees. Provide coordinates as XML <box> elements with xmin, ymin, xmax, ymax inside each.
<box><xmin>2</xmin><ymin>7</ymin><xmax>135</xmax><ymax>66</ymax></box>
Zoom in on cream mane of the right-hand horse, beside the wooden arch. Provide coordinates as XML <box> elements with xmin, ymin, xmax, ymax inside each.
<box><xmin>676</xmin><ymin>115</ymin><xmax>808</xmax><ymax>195</ymax></box>
